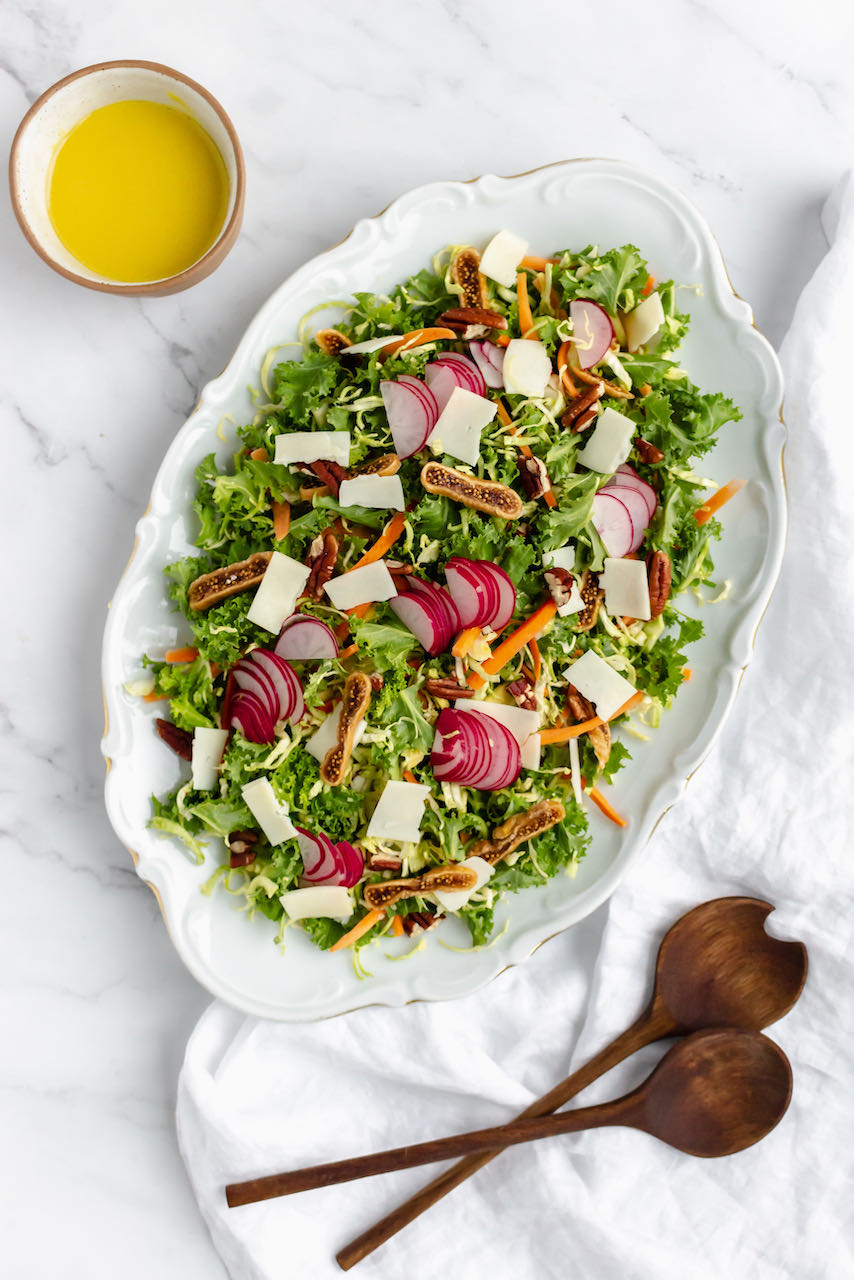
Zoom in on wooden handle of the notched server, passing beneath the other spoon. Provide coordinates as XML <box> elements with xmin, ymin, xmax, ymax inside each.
<box><xmin>337</xmin><ymin>1006</ymin><xmax>676</xmax><ymax>1271</ymax></box>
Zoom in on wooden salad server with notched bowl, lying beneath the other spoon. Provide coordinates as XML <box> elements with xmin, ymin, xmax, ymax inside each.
<box><xmin>338</xmin><ymin>897</ymin><xmax>807</xmax><ymax>1271</ymax></box>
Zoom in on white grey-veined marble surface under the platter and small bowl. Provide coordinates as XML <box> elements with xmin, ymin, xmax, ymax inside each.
<box><xmin>0</xmin><ymin>0</ymin><xmax>854</xmax><ymax>1280</ymax></box>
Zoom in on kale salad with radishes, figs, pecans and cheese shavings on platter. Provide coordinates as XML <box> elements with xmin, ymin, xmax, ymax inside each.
<box><xmin>136</xmin><ymin>230</ymin><xmax>741</xmax><ymax>968</ymax></box>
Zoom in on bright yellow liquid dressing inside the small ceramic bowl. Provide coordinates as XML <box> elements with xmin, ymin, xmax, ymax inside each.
<box><xmin>47</xmin><ymin>101</ymin><xmax>229</xmax><ymax>283</ymax></box>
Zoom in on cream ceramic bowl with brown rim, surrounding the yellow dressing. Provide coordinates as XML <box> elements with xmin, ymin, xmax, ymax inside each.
<box><xmin>9</xmin><ymin>61</ymin><xmax>246</xmax><ymax>296</ymax></box>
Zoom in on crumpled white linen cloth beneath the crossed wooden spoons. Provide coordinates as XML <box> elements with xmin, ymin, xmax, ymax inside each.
<box><xmin>178</xmin><ymin>183</ymin><xmax>854</xmax><ymax>1280</ymax></box>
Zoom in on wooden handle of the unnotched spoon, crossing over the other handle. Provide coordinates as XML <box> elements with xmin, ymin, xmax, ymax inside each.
<box><xmin>225</xmin><ymin>1098</ymin><xmax>631</xmax><ymax>1208</ymax></box>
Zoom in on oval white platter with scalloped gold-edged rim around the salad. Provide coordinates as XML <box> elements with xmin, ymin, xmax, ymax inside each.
<box><xmin>102</xmin><ymin>160</ymin><xmax>786</xmax><ymax>1021</ymax></box>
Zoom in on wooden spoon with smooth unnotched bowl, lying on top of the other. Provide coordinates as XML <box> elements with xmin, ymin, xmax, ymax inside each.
<box><xmin>225</xmin><ymin>1027</ymin><xmax>791</xmax><ymax>1207</ymax></box>
